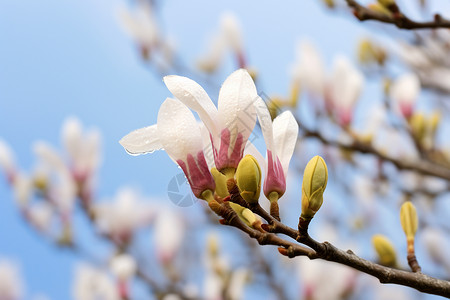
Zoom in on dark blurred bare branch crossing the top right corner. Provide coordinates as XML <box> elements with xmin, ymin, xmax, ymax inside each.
<box><xmin>346</xmin><ymin>0</ymin><xmax>450</xmax><ymax>29</ymax></box>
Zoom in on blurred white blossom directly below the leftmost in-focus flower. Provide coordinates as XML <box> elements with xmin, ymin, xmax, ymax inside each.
<box><xmin>154</xmin><ymin>208</ymin><xmax>184</xmax><ymax>263</ymax></box>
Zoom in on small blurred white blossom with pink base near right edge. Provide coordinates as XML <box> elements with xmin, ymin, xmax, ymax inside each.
<box><xmin>389</xmin><ymin>73</ymin><xmax>420</xmax><ymax>118</ymax></box>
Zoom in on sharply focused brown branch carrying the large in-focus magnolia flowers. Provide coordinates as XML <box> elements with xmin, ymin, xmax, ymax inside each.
<box><xmin>220</xmin><ymin>183</ymin><xmax>450</xmax><ymax>298</ymax></box>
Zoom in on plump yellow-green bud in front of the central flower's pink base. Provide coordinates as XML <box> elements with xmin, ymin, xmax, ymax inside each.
<box><xmin>236</xmin><ymin>155</ymin><xmax>261</xmax><ymax>203</ymax></box>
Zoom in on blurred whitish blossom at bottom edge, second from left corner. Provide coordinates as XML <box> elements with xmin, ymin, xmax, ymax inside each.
<box><xmin>73</xmin><ymin>264</ymin><xmax>120</xmax><ymax>300</ymax></box>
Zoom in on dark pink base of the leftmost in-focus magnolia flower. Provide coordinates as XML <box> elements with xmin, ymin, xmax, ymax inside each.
<box><xmin>177</xmin><ymin>151</ymin><xmax>216</xmax><ymax>198</ymax></box>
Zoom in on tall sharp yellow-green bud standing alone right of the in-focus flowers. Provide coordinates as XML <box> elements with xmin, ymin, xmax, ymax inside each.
<box><xmin>302</xmin><ymin>155</ymin><xmax>328</xmax><ymax>219</ymax></box>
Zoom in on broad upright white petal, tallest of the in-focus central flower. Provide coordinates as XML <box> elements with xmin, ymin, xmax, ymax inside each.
<box><xmin>219</xmin><ymin>69</ymin><xmax>258</xmax><ymax>146</ymax></box>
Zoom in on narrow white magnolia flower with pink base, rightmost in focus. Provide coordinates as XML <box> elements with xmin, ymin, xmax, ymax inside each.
<box><xmin>255</xmin><ymin>97</ymin><xmax>298</xmax><ymax>198</ymax></box>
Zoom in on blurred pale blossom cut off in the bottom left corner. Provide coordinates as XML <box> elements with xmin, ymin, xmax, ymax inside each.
<box><xmin>0</xmin><ymin>260</ymin><xmax>24</xmax><ymax>300</ymax></box>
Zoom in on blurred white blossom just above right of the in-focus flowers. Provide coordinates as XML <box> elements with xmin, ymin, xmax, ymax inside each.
<box><xmin>291</xmin><ymin>40</ymin><xmax>325</xmax><ymax>99</ymax></box>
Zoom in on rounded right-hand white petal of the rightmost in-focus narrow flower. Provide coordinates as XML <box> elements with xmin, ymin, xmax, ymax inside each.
<box><xmin>273</xmin><ymin>111</ymin><xmax>298</xmax><ymax>176</ymax></box>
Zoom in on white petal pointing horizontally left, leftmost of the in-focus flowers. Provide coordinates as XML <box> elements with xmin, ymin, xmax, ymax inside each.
<box><xmin>119</xmin><ymin>124</ymin><xmax>163</xmax><ymax>155</ymax></box>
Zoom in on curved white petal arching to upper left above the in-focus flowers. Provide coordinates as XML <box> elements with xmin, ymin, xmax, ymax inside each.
<box><xmin>164</xmin><ymin>75</ymin><xmax>219</xmax><ymax>136</ymax></box>
